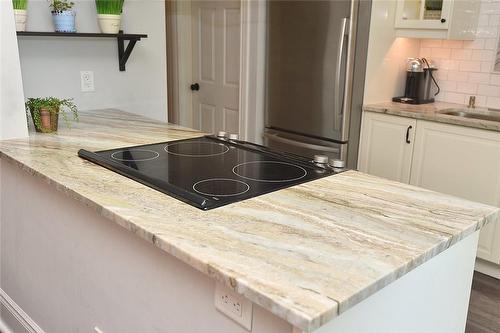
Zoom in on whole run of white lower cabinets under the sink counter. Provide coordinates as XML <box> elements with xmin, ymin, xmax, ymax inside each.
<box><xmin>358</xmin><ymin>112</ymin><xmax>500</xmax><ymax>264</ymax></box>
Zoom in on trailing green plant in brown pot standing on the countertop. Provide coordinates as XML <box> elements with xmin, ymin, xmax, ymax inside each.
<box><xmin>26</xmin><ymin>97</ymin><xmax>78</xmax><ymax>133</ymax></box>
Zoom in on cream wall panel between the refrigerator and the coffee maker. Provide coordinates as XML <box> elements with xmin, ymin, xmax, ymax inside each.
<box><xmin>364</xmin><ymin>0</ymin><xmax>420</xmax><ymax>104</ymax></box>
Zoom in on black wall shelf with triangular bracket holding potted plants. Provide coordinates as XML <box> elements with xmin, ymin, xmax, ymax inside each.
<box><xmin>17</xmin><ymin>30</ymin><xmax>148</xmax><ymax>71</ymax></box>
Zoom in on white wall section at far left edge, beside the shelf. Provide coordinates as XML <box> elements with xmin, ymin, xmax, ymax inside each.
<box><xmin>0</xmin><ymin>0</ymin><xmax>28</xmax><ymax>140</ymax></box>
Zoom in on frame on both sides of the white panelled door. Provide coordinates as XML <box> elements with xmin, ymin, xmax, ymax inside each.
<box><xmin>165</xmin><ymin>0</ymin><xmax>266</xmax><ymax>142</ymax></box>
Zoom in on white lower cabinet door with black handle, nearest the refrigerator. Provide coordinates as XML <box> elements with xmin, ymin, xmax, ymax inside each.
<box><xmin>358</xmin><ymin>112</ymin><xmax>417</xmax><ymax>183</ymax></box>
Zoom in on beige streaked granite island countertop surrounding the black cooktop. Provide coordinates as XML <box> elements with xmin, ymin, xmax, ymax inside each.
<box><xmin>0</xmin><ymin>110</ymin><xmax>498</xmax><ymax>330</ymax></box>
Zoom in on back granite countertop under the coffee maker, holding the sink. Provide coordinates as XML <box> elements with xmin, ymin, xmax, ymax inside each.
<box><xmin>363</xmin><ymin>102</ymin><xmax>500</xmax><ymax>132</ymax></box>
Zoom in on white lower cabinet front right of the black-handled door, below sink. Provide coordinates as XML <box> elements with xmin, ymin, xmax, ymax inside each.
<box><xmin>410</xmin><ymin>121</ymin><xmax>500</xmax><ymax>264</ymax></box>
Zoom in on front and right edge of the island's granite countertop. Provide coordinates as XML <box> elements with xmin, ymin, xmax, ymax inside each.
<box><xmin>0</xmin><ymin>151</ymin><xmax>500</xmax><ymax>331</ymax></box>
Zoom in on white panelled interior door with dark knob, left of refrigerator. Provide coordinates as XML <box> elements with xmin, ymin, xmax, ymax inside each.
<box><xmin>191</xmin><ymin>0</ymin><xmax>241</xmax><ymax>133</ymax></box>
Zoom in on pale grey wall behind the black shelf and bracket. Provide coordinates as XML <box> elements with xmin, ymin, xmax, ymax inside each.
<box><xmin>19</xmin><ymin>0</ymin><xmax>167</xmax><ymax>121</ymax></box>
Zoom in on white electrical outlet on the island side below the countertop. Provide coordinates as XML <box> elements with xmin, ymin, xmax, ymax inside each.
<box><xmin>215</xmin><ymin>283</ymin><xmax>253</xmax><ymax>331</ymax></box>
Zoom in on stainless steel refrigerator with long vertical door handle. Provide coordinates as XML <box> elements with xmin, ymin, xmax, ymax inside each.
<box><xmin>264</xmin><ymin>0</ymin><xmax>371</xmax><ymax>168</ymax></box>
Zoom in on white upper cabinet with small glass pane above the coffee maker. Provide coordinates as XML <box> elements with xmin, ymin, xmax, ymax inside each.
<box><xmin>395</xmin><ymin>0</ymin><xmax>480</xmax><ymax>40</ymax></box>
